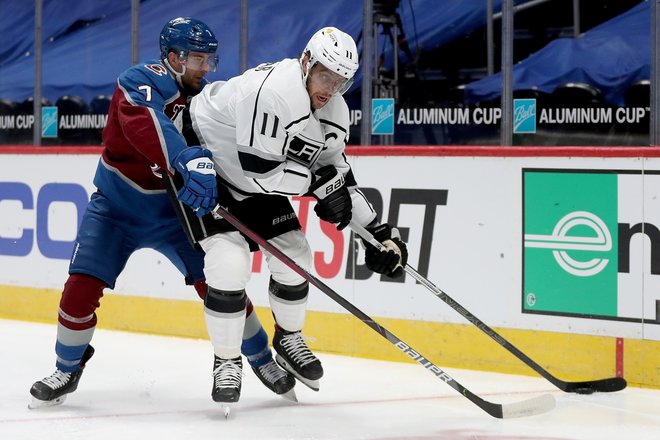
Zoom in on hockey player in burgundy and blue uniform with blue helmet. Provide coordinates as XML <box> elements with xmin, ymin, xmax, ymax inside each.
<box><xmin>30</xmin><ymin>18</ymin><xmax>295</xmax><ymax>408</ymax></box>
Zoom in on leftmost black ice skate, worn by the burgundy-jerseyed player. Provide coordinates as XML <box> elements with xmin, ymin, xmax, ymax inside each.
<box><xmin>28</xmin><ymin>345</ymin><xmax>94</xmax><ymax>409</ymax></box>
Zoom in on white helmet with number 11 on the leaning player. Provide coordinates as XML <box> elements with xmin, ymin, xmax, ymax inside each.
<box><xmin>301</xmin><ymin>27</ymin><xmax>360</xmax><ymax>94</ymax></box>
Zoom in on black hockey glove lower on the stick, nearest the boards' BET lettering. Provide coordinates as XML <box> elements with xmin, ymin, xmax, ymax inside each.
<box><xmin>364</xmin><ymin>223</ymin><xmax>408</xmax><ymax>278</ymax></box>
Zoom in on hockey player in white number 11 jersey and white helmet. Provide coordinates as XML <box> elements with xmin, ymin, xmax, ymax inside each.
<box><xmin>173</xmin><ymin>27</ymin><xmax>407</xmax><ymax>402</ymax></box>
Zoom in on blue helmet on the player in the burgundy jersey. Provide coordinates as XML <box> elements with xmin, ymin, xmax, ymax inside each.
<box><xmin>160</xmin><ymin>17</ymin><xmax>218</xmax><ymax>60</ymax></box>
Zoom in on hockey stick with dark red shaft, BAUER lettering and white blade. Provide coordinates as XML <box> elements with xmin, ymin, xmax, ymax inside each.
<box><xmin>212</xmin><ymin>205</ymin><xmax>555</xmax><ymax>419</ymax></box>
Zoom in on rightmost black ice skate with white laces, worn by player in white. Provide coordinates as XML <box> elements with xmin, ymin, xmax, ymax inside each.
<box><xmin>273</xmin><ymin>328</ymin><xmax>323</xmax><ymax>391</ymax></box>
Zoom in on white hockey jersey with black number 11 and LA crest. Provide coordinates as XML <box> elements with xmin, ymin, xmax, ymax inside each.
<box><xmin>190</xmin><ymin>59</ymin><xmax>376</xmax><ymax>226</ymax></box>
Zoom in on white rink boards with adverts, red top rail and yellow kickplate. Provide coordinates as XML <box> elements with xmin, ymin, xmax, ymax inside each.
<box><xmin>0</xmin><ymin>147</ymin><xmax>660</xmax><ymax>388</ymax></box>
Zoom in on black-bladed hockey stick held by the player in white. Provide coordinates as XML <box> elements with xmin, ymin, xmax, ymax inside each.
<box><xmin>350</xmin><ymin>222</ymin><xmax>627</xmax><ymax>394</ymax></box>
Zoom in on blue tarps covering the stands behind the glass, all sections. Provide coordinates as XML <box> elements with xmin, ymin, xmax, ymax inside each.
<box><xmin>0</xmin><ymin>0</ymin><xmax>651</xmax><ymax>105</ymax></box>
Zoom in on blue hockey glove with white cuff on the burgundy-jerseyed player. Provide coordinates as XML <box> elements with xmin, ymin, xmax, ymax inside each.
<box><xmin>174</xmin><ymin>147</ymin><xmax>218</xmax><ymax>217</ymax></box>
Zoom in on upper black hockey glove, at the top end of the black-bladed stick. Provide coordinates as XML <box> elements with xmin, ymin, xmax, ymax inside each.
<box><xmin>307</xmin><ymin>165</ymin><xmax>353</xmax><ymax>231</ymax></box>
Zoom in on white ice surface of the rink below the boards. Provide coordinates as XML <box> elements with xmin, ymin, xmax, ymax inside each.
<box><xmin>0</xmin><ymin>320</ymin><xmax>660</xmax><ymax>440</ymax></box>
